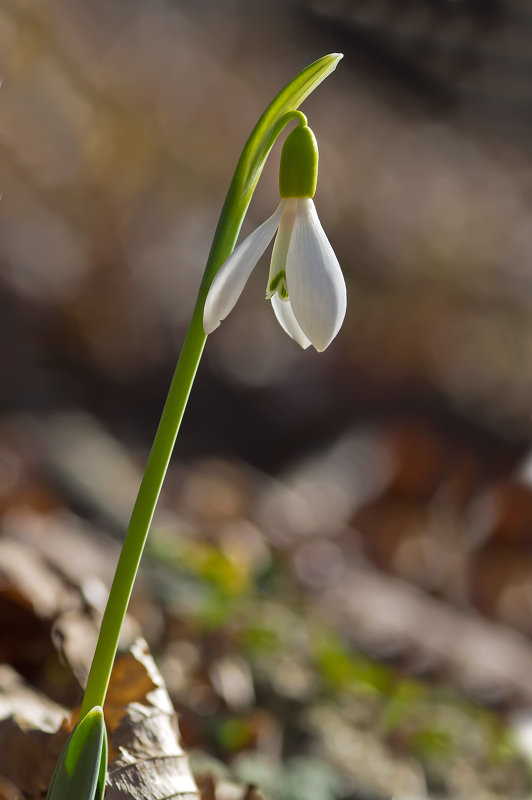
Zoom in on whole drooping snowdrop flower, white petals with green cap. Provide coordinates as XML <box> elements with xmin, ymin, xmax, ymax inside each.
<box><xmin>203</xmin><ymin>125</ymin><xmax>347</xmax><ymax>352</ymax></box>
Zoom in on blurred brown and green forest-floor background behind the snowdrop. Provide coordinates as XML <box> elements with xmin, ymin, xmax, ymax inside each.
<box><xmin>5</xmin><ymin>0</ymin><xmax>532</xmax><ymax>800</ymax></box>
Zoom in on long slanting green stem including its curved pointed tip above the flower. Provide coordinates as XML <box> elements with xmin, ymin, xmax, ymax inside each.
<box><xmin>80</xmin><ymin>54</ymin><xmax>341</xmax><ymax>721</ymax></box>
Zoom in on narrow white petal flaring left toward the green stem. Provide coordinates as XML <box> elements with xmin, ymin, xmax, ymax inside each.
<box><xmin>203</xmin><ymin>200</ymin><xmax>285</xmax><ymax>333</ymax></box>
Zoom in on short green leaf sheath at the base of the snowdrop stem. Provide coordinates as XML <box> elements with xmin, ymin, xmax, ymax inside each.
<box><xmin>46</xmin><ymin>706</ymin><xmax>107</xmax><ymax>800</ymax></box>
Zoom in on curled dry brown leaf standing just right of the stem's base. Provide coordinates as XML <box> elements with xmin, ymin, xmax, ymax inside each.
<box><xmin>105</xmin><ymin>639</ymin><xmax>199</xmax><ymax>800</ymax></box>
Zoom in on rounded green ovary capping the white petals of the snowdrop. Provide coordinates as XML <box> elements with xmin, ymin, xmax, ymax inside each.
<box><xmin>279</xmin><ymin>125</ymin><xmax>318</xmax><ymax>202</ymax></box>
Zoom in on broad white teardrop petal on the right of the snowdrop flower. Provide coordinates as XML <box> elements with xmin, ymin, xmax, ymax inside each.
<box><xmin>286</xmin><ymin>197</ymin><xmax>347</xmax><ymax>352</ymax></box>
